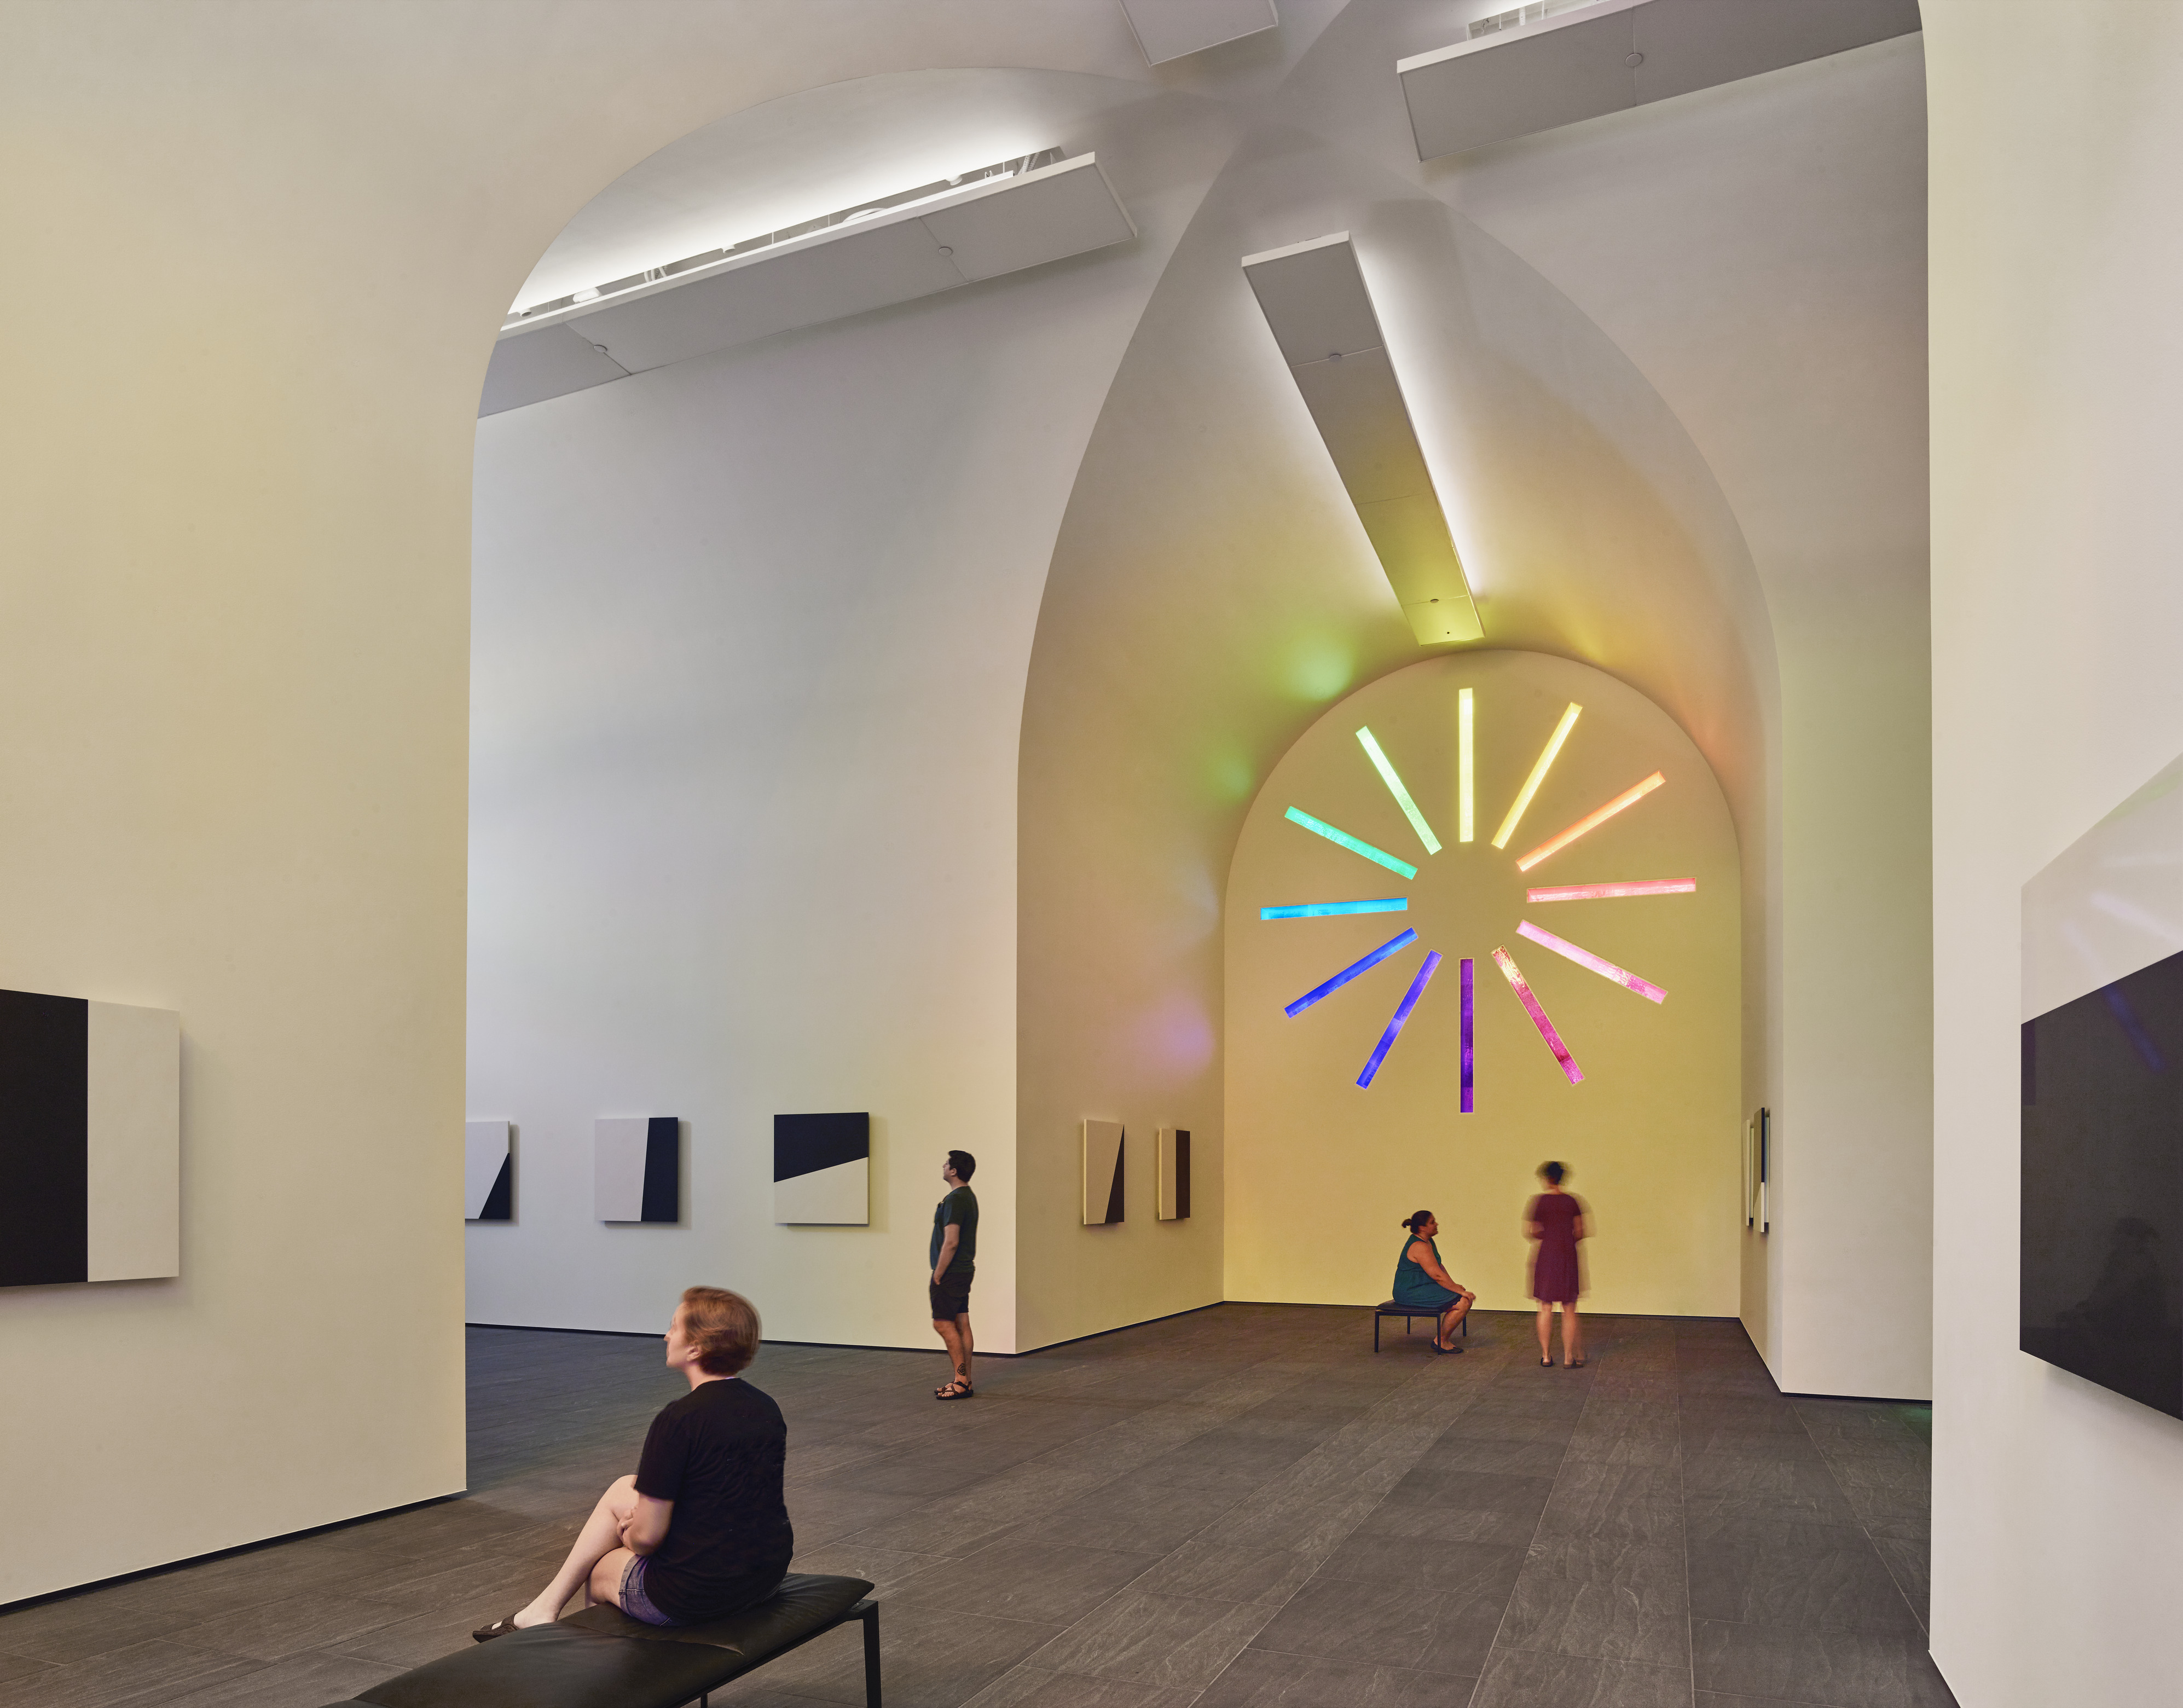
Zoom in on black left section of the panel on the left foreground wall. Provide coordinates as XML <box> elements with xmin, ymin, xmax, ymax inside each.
<box><xmin>0</xmin><ymin>989</ymin><xmax>92</xmax><ymax>1287</ymax></box>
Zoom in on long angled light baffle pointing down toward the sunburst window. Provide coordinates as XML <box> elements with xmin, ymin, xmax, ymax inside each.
<box><xmin>1242</xmin><ymin>231</ymin><xmax>1485</xmax><ymax>646</ymax></box>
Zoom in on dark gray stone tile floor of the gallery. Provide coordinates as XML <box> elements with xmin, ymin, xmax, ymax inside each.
<box><xmin>0</xmin><ymin>1304</ymin><xmax>1954</xmax><ymax>1708</ymax></box>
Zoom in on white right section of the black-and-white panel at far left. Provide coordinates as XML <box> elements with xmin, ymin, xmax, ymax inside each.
<box><xmin>83</xmin><ymin>1003</ymin><xmax>181</xmax><ymax>1280</ymax></box>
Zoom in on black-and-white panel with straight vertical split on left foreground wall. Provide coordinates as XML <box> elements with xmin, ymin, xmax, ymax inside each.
<box><xmin>0</xmin><ymin>992</ymin><xmax>181</xmax><ymax>1287</ymax></box>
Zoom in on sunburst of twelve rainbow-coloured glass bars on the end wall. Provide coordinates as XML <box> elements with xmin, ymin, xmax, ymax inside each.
<box><xmin>1260</xmin><ymin>708</ymin><xmax>1698</xmax><ymax>1096</ymax></box>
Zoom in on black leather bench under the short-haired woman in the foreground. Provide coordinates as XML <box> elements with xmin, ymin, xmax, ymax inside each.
<box><xmin>327</xmin><ymin>1573</ymin><xmax>880</xmax><ymax>1708</ymax></box>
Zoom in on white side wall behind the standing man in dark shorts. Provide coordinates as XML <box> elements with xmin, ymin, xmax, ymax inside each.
<box><xmin>467</xmin><ymin>72</ymin><xmax>1227</xmax><ymax>1352</ymax></box>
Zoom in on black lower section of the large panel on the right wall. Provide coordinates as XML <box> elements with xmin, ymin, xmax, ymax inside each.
<box><xmin>2017</xmin><ymin>954</ymin><xmax>2183</xmax><ymax>1417</ymax></box>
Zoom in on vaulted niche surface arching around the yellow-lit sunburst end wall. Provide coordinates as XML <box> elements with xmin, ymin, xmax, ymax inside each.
<box><xmin>1017</xmin><ymin>126</ymin><xmax>1777</xmax><ymax>1345</ymax></box>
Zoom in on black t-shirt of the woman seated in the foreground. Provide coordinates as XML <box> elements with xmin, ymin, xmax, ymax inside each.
<box><xmin>638</xmin><ymin>1376</ymin><xmax>795</xmax><ymax>1625</ymax></box>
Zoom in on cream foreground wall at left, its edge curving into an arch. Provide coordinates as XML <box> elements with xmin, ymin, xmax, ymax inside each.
<box><xmin>0</xmin><ymin>0</ymin><xmax>1179</xmax><ymax>1601</ymax></box>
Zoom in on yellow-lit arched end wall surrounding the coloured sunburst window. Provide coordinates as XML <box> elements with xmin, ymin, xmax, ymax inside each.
<box><xmin>1227</xmin><ymin>651</ymin><xmax>1742</xmax><ymax>1317</ymax></box>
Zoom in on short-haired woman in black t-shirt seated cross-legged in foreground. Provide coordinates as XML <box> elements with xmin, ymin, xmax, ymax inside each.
<box><xmin>472</xmin><ymin>1287</ymin><xmax>795</xmax><ymax>1642</ymax></box>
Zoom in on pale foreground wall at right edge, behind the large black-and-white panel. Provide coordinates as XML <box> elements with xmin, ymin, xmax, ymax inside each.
<box><xmin>1925</xmin><ymin>0</ymin><xmax>2183</xmax><ymax>1708</ymax></box>
